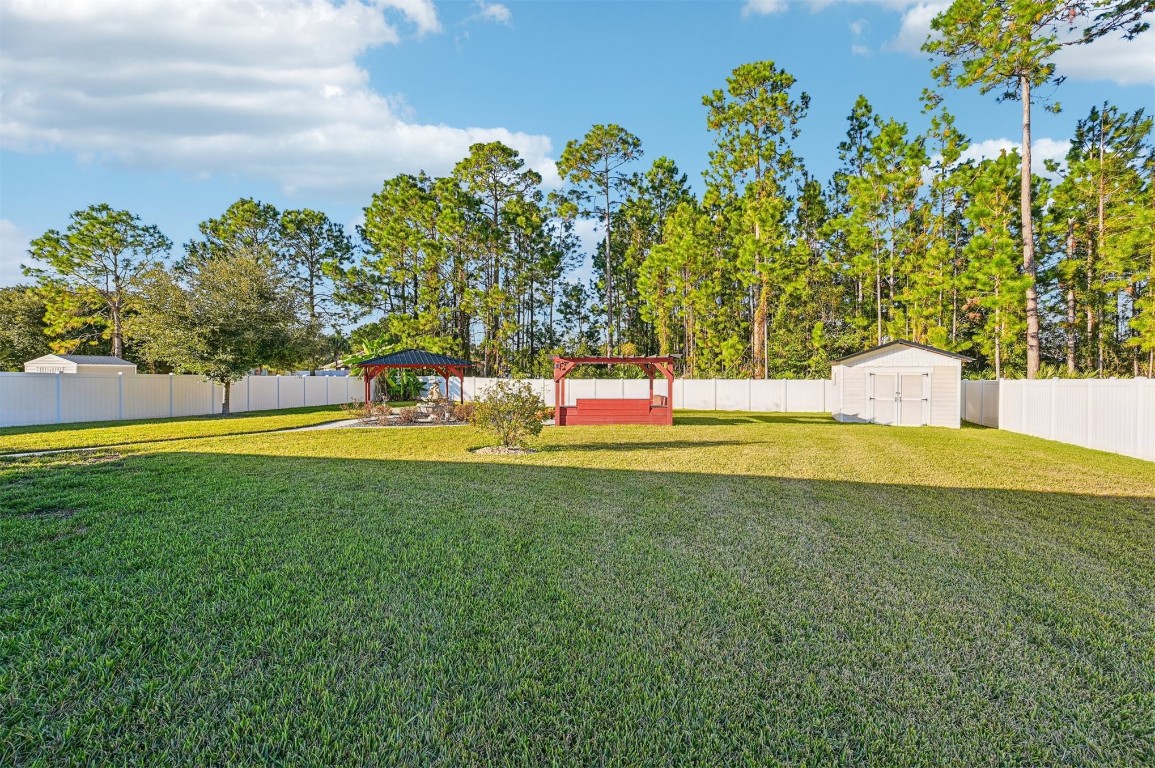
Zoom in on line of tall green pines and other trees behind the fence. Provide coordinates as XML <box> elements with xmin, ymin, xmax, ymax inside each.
<box><xmin>0</xmin><ymin>0</ymin><xmax>1155</xmax><ymax>381</ymax></box>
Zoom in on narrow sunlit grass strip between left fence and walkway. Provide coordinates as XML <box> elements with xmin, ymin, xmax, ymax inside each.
<box><xmin>0</xmin><ymin>405</ymin><xmax>349</xmax><ymax>455</ymax></box>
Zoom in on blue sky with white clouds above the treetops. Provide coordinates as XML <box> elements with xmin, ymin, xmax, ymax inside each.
<box><xmin>0</xmin><ymin>0</ymin><xmax>1155</xmax><ymax>284</ymax></box>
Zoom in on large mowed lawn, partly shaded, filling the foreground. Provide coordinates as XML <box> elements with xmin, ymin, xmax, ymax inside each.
<box><xmin>0</xmin><ymin>413</ymin><xmax>1155</xmax><ymax>766</ymax></box>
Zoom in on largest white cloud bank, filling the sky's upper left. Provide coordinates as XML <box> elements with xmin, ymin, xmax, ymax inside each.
<box><xmin>0</xmin><ymin>0</ymin><xmax>557</xmax><ymax>195</ymax></box>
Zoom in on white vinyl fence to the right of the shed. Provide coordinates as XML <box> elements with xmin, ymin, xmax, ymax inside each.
<box><xmin>962</xmin><ymin>379</ymin><xmax>1155</xmax><ymax>461</ymax></box>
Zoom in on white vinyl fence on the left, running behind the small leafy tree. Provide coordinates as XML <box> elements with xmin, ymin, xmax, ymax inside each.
<box><xmin>0</xmin><ymin>373</ymin><xmax>365</xmax><ymax>426</ymax></box>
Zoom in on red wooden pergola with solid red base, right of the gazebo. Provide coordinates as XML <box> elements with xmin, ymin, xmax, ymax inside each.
<box><xmin>553</xmin><ymin>356</ymin><xmax>673</xmax><ymax>426</ymax></box>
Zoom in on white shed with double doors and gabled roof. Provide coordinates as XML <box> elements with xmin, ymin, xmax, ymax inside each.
<box><xmin>832</xmin><ymin>341</ymin><xmax>971</xmax><ymax>428</ymax></box>
